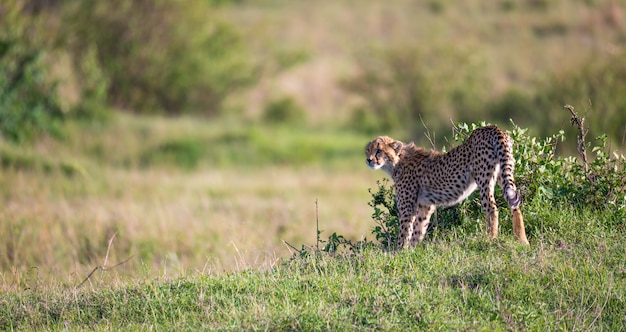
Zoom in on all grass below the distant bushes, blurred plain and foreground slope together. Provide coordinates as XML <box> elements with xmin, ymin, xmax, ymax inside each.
<box><xmin>0</xmin><ymin>115</ymin><xmax>626</xmax><ymax>331</ymax></box>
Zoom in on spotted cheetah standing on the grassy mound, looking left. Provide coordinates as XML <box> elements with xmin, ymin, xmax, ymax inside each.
<box><xmin>365</xmin><ymin>126</ymin><xmax>528</xmax><ymax>249</ymax></box>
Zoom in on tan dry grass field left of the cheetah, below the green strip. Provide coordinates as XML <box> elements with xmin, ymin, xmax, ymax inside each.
<box><xmin>0</xmin><ymin>126</ymin><xmax>380</xmax><ymax>288</ymax></box>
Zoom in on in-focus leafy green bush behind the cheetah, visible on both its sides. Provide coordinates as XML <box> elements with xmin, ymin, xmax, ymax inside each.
<box><xmin>310</xmin><ymin>123</ymin><xmax>626</xmax><ymax>255</ymax></box>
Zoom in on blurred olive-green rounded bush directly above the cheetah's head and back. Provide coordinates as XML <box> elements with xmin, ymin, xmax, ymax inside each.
<box><xmin>341</xmin><ymin>46</ymin><xmax>490</xmax><ymax>136</ymax></box>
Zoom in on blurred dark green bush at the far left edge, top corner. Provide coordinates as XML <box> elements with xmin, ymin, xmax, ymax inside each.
<box><xmin>0</xmin><ymin>0</ymin><xmax>62</xmax><ymax>142</ymax></box>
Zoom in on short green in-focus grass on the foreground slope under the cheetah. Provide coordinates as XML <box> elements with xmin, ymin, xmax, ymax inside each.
<box><xmin>0</xmin><ymin>208</ymin><xmax>626</xmax><ymax>331</ymax></box>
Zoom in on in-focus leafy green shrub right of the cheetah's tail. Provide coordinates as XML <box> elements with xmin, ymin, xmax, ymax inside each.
<box><xmin>455</xmin><ymin>120</ymin><xmax>626</xmax><ymax>213</ymax></box>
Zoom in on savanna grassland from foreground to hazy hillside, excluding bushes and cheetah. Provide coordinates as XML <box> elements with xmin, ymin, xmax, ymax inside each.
<box><xmin>0</xmin><ymin>1</ymin><xmax>626</xmax><ymax>330</ymax></box>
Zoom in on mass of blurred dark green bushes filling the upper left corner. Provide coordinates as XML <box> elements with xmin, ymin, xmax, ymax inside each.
<box><xmin>0</xmin><ymin>0</ymin><xmax>260</xmax><ymax>141</ymax></box>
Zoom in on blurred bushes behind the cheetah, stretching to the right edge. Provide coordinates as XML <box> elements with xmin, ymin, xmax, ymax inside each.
<box><xmin>342</xmin><ymin>43</ymin><xmax>626</xmax><ymax>146</ymax></box>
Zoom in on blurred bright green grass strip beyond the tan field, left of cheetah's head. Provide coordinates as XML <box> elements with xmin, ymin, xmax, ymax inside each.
<box><xmin>50</xmin><ymin>114</ymin><xmax>371</xmax><ymax>170</ymax></box>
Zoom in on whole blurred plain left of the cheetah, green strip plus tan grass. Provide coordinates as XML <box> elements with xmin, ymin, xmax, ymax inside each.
<box><xmin>0</xmin><ymin>116</ymin><xmax>382</xmax><ymax>289</ymax></box>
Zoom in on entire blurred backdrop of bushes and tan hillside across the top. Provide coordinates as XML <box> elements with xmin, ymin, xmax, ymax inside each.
<box><xmin>0</xmin><ymin>0</ymin><xmax>626</xmax><ymax>150</ymax></box>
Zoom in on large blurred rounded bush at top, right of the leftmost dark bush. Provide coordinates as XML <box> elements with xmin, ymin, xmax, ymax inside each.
<box><xmin>63</xmin><ymin>0</ymin><xmax>257</xmax><ymax>115</ymax></box>
